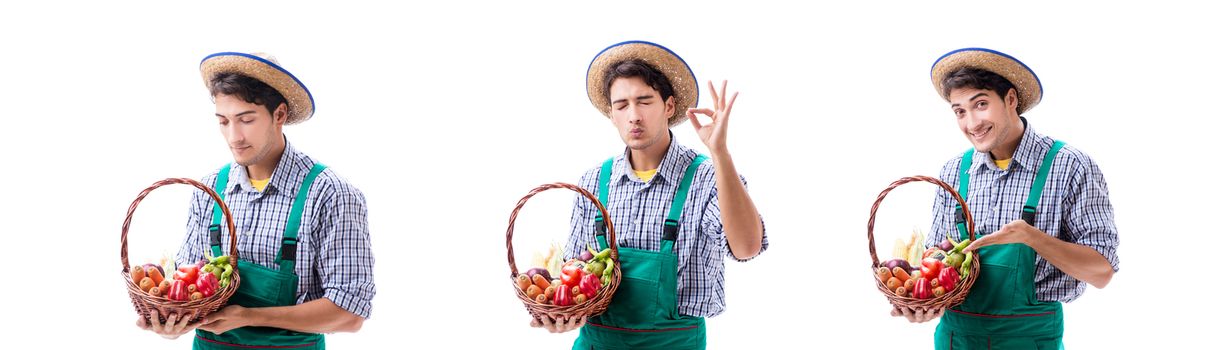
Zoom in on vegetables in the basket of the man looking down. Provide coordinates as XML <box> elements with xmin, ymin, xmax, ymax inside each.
<box><xmin>130</xmin><ymin>256</ymin><xmax>234</xmax><ymax>302</ymax></box>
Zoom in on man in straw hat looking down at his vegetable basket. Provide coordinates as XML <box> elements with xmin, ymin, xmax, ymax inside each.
<box><xmin>138</xmin><ymin>52</ymin><xmax>375</xmax><ymax>349</ymax></box>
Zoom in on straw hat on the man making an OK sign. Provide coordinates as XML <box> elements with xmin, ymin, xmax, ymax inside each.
<box><xmin>587</xmin><ymin>41</ymin><xmax>700</xmax><ymax>127</ymax></box>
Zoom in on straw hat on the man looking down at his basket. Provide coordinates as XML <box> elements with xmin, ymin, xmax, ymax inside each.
<box><xmin>202</xmin><ymin>52</ymin><xmax>314</xmax><ymax>124</ymax></box>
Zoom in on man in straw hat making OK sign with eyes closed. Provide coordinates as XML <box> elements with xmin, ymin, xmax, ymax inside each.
<box><xmin>532</xmin><ymin>41</ymin><xmax>768</xmax><ymax>349</ymax></box>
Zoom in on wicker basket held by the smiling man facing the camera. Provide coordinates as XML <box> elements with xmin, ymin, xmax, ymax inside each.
<box><xmin>868</xmin><ymin>176</ymin><xmax>980</xmax><ymax>310</ymax></box>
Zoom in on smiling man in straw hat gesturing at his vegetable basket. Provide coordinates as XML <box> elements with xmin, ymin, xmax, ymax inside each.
<box><xmin>892</xmin><ymin>48</ymin><xmax>1119</xmax><ymax>349</ymax></box>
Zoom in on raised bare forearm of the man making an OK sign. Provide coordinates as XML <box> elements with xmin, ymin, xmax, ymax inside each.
<box><xmin>712</xmin><ymin>152</ymin><xmax>763</xmax><ymax>259</ymax></box>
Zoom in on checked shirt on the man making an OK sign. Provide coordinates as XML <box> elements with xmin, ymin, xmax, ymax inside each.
<box><xmin>566</xmin><ymin>136</ymin><xmax>766</xmax><ymax>317</ymax></box>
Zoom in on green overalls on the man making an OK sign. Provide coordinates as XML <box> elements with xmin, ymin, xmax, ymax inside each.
<box><xmin>573</xmin><ymin>154</ymin><xmax>707</xmax><ymax>350</ymax></box>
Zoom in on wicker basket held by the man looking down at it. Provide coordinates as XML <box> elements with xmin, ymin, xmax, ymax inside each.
<box><xmin>122</xmin><ymin>179</ymin><xmax>239</xmax><ymax>323</ymax></box>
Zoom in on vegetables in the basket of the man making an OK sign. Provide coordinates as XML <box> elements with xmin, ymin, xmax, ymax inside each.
<box><xmin>514</xmin><ymin>247</ymin><xmax>616</xmax><ymax>307</ymax></box>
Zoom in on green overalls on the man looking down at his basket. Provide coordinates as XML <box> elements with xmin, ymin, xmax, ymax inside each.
<box><xmin>193</xmin><ymin>163</ymin><xmax>326</xmax><ymax>349</ymax></box>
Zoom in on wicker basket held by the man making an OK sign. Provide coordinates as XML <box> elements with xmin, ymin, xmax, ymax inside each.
<box><xmin>507</xmin><ymin>182</ymin><xmax>620</xmax><ymax>321</ymax></box>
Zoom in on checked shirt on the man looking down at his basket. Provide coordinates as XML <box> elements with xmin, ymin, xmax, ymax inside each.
<box><xmin>176</xmin><ymin>141</ymin><xmax>377</xmax><ymax>317</ymax></box>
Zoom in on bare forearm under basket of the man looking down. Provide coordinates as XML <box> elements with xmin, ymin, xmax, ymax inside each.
<box><xmin>247</xmin><ymin>298</ymin><xmax>365</xmax><ymax>333</ymax></box>
